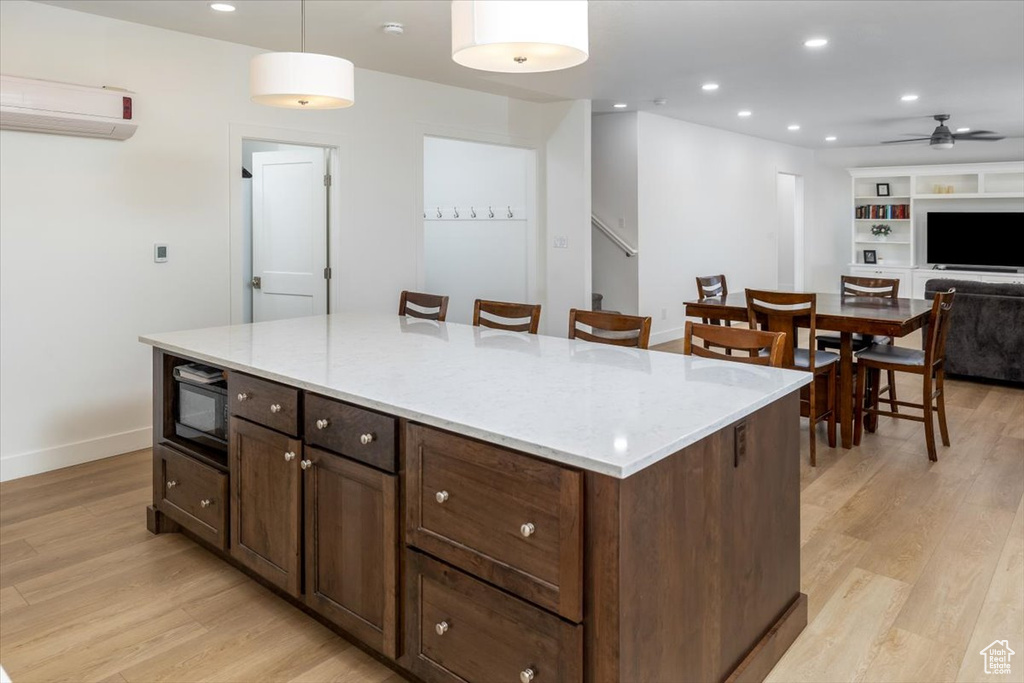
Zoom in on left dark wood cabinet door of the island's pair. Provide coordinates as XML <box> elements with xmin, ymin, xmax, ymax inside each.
<box><xmin>229</xmin><ymin>418</ymin><xmax>302</xmax><ymax>596</ymax></box>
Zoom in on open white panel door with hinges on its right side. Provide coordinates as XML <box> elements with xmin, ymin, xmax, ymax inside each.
<box><xmin>252</xmin><ymin>148</ymin><xmax>328</xmax><ymax>323</ymax></box>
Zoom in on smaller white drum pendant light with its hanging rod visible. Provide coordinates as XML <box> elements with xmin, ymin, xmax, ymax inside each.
<box><xmin>249</xmin><ymin>0</ymin><xmax>355</xmax><ymax>110</ymax></box>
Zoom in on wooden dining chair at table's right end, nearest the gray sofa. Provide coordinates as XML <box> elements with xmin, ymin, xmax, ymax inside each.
<box><xmin>853</xmin><ymin>288</ymin><xmax>956</xmax><ymax>462</ymax></box>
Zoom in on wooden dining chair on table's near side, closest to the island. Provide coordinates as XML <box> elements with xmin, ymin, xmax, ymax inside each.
<box><xmin>745</xmin><ymin>289</ymin><xmax>839</xmax><ymax>467</ymax></box>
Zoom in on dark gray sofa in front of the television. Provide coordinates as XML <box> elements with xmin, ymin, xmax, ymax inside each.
<box><xmin>925</xmin><ymin>279</ymin><xmax>1024</xmax><ymax>383</ymax></box>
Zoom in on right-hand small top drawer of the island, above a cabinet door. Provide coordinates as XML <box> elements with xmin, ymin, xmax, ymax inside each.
<box><xmin>303</xmin><ymin>393</ymin><xmax>397</xmax><ymax>472</ymax></box>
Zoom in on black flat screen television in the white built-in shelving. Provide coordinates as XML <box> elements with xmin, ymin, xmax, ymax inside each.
<box><xmin>927</xmin><ymin>211</ymin><xmax>1024</xmax><ymax>268</ymax></box>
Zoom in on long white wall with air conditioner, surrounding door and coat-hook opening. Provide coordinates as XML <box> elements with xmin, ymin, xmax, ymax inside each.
<box><xmin>0</xmin><ymin>0</ymin><xmax>590</xmax><ymax>478</ymax></box>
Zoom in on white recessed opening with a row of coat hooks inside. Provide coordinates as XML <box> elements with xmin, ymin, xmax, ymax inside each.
<box><xmin>423</xmin><ymin>135</ymin><xmax>537</xmax><ymax>324</ymax></box>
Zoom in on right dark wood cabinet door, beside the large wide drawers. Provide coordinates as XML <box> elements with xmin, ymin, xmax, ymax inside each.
<box><xmin>304</xmin><ymin>447</ymin><xmax>398</xmax><ymax>658</ymax></box>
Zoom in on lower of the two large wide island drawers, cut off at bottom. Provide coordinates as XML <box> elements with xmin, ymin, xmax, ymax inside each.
<box><xmin>403</xmin><ymin>551</ymin><xmax>583</xmax><ymax>683</ymax></box>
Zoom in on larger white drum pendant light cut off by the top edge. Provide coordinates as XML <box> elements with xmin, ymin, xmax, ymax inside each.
<box><xmin>452</xmin><ymin>0</ymin><xmax>590</xmax><ymax>74</ymax></box>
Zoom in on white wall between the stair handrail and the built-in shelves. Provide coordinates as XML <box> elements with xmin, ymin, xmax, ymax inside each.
<box><xmin>638</xmin><ymin>112</ymin><xmax>819</xmax><ymax>344</ymax></box>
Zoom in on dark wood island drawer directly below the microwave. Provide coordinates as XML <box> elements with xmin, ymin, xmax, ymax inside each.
<box><xmin>153</xmin><ymin>445</ymin><xmax>228</xmax><ymax>549</ymax></box>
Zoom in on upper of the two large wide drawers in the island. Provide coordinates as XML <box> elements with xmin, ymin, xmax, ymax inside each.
<box><xmin>406</xmin><ymin>425</ymin><xmax>583</xmax><ymax>622</ymax></box>
